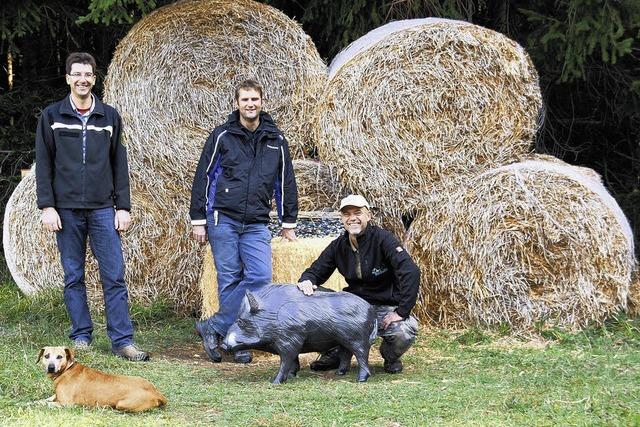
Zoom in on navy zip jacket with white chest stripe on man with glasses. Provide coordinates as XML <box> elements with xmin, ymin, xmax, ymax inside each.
<box><xmin>36</xmin><ymin>96</ymin><xmax>131</xmax><ymax>210</ymax></box>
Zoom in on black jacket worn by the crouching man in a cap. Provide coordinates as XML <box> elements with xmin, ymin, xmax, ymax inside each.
<box><xmin>299</xmin><ymin>224</ymin><xmax>420</xmax><ymax>319</ymax></box>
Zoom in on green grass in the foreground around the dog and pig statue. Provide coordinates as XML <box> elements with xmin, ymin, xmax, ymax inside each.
<box><xmin>0</xmin><ymin>283</ymin><xmax>640</xmax><ymax>426</ymax></box>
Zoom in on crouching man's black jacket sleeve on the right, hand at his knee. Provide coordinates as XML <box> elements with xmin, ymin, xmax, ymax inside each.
<box><xmin>382</xmin><ymin>231</ymin><xmax>420</xmax><ymax>319</ymax></box>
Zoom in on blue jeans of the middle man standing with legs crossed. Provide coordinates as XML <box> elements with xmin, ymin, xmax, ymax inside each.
<box><xmin>207</xmin><ymin>211</ymin><xmax>271</xmax><ymax>337</ymax></box>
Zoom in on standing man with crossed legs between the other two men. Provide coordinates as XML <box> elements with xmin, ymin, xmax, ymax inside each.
<box><xmin>190</xmin><ymin>80</ymin><xmax>298</xmax><ymax>363</ymax></box>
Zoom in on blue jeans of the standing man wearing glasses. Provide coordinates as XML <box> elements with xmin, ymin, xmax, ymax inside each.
<box><xmin>56</xmin><ymin>208</ymin><xmax>133</xmax><ymax>349</ymax></box>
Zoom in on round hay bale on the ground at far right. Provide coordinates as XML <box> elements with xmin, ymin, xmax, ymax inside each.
<box><xmin>407</xmin><ymin>161</ymin><xmax>634</xmax><ymax>330</ymax></box>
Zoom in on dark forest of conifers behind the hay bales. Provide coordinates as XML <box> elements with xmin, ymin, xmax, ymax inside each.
<box><xmin>0</xmin><ymin>0</ymin><xmax>640</xmax><ymax>260</ymax></box>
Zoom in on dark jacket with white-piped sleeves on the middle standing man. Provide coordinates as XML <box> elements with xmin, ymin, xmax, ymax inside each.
<box><xmin>189</xmin><ymin>110</ymin><xmax>298</xmax><ymax>228</ymax></box>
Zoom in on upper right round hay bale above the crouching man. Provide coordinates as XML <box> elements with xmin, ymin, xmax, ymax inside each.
<box><xmin>314</xmin><ymin>19</ymin><xmax>542</xmax><ymax>217</ymax></box>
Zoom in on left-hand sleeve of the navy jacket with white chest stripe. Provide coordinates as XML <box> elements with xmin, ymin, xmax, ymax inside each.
<box><xmin>36</xmin><ymin>110</ymin><xmax>56</xmax><ymax>209</ymax></box>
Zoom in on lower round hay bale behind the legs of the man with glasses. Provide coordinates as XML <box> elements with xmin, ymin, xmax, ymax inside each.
<box><xmin>3</xmin><ymin>169</ymin><xmax>202</xmax><ymax>311</ymax></box>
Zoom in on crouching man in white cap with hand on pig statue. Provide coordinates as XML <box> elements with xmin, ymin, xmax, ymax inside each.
<box><xmin>298</xmin><ymin>195</ymin><xmax>420</xmax><ymax>374</ymax></box>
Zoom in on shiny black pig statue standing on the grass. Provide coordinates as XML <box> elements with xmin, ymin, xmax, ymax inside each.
<box><xmin>222</xmin><ymin>284</ymin><xmax>377</xmax><ymax>384</ymax></box>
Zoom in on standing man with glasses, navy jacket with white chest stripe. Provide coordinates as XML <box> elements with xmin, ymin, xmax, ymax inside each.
<box><xmin>36</xmin><ymin>52</ymin><xmax>149</xmax><ymax>361</ymax></box>
